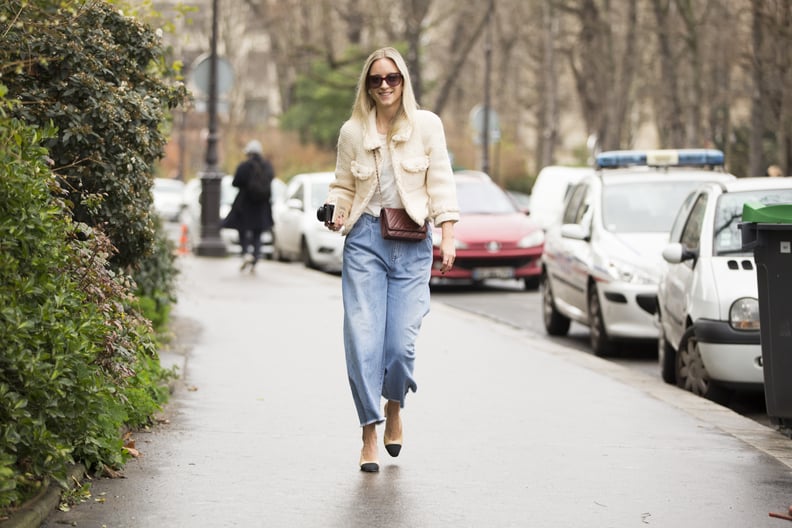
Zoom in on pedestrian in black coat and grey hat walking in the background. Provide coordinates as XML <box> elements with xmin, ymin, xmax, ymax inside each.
<box><xmin>223</xmin><ymin>139</ymin><xmax>275</xmax><ymax>272</ymax></box>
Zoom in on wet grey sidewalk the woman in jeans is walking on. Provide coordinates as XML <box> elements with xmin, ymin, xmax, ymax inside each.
<box><xmin>31</xmin><ymin>256</ymin><xmax>792</xmax><ymax>528</ymax></box>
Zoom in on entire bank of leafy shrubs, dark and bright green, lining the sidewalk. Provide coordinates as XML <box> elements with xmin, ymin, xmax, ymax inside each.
<box><xmin>0</xmin><ymin>0</ymin><xmax>186</xmax><ymax>511</ymax></box>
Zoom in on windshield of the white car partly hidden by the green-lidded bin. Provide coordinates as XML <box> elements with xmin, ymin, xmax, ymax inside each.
<box><xmin>713</xmin><ymin>189</ymin><xmax>792</xmax><ymax>255</ymax></box>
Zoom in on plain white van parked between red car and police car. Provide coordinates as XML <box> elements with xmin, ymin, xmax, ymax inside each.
<box><xmin>530</xmin><ymin>165</ymin><xmax>594</xmax><ymax>231</ymax></box>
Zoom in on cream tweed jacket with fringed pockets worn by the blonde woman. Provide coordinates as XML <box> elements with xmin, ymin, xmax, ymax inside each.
<box><xmin>327</xmin><ymin>110</ymin><xmax>459</xmax><ymax>234</ymax></box>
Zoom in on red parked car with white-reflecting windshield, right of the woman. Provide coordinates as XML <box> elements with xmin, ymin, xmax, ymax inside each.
<box><xmin>432</xmin><ymin>171</ymin><xmax>544</xmax><ymax>289</ymax></box>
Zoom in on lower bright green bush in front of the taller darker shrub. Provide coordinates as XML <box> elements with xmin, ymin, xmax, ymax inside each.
<box><xmin>0</xmin><ymin>97</ymin><xmax>172</xmax><ymax>510</ymax></box>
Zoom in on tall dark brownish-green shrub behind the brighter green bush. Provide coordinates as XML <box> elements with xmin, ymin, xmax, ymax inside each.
<box><xmin>0</xmin><ymin>0</ymin><xmax>186</xmax><ymax>284</ymax></box>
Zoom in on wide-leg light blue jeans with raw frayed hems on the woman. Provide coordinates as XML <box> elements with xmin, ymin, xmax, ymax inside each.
<box><xmin>341</xmin><ymin>214</ymin><xmax>432</xmax><ymax>426</ymax></box>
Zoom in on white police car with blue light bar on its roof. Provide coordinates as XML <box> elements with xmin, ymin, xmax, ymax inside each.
<box><xmin>541</xmin><ymin>150</ymin><xmax>735</xmax><ymax>356</ymax></box>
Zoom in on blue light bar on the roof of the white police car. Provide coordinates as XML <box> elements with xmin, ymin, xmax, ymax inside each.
<box><xmin>596</xmin><ymin>149</ymin><xmax>724</xmax><ymax>169</ymax></box>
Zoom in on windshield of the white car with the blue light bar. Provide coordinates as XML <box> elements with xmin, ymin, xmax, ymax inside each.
<box><xmin>602</xmin><ymin>180</ymin><xmax>716</xmax><ymax>233</ymax></box>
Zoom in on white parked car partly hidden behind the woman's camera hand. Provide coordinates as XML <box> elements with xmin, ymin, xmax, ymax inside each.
<box><xmin>273</xmin><ymin>172</ymin><xmax>344</xmax><ymax>272</ymax></box>
